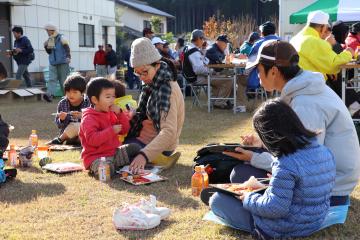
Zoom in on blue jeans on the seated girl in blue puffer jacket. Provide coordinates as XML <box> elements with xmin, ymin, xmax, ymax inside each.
<box><xmin>209</xmin><ymin>192</ymin><xmax>255</xmax><ymax>233</ymax></box>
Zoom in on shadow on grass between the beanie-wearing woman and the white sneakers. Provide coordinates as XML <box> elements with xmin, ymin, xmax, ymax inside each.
<box><xmin>109</xmin><ymin>164</ymin><xmax>199</xmax><ymax>209</ymax></box>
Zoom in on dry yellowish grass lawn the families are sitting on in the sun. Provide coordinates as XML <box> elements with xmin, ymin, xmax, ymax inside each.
<box><xmin>0</xmin><ymin>100</ymin><xmax>360</xmax><ymax>240</ymax></box>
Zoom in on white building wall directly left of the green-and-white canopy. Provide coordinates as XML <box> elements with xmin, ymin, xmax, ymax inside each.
<box><xmin>279</xmin><ymin>0</ymin><xmax>316</xmax><ymax>41</ymax></box>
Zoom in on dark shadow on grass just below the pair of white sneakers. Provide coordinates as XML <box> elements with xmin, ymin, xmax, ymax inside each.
<box><xmin>117</xmin><ymin>220</ymin><xmax>175</xmax><ymax>240</ymax></box>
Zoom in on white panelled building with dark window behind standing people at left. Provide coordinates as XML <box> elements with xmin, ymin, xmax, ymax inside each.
<box><xmin>0</xmin><ymin>0</ymin><xmax>116</xmax><ymax>79</ymax></box>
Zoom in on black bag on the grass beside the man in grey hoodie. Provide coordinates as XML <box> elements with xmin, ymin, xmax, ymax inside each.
<box><xmin>193</xmin><ymin>143</ymin><xmax>264</xmax><ymax>184</ymax></box>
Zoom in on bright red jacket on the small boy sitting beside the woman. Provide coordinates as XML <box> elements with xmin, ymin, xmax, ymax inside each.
<box><xmin>79</xmin><ymin>107</ymin><xmax>130</xmax><ymax>169</ymax></box>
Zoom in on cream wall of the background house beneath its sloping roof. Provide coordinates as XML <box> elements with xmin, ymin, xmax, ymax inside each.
<box><xmin>116</xmin><ymin>4</ymin><xmax>167</xmax><ymax>33</ymax></box>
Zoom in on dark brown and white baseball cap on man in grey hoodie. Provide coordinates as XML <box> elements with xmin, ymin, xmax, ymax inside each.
<box><xmin>246</xmin><ymin>40</ymin><xmax>299</xmax><ymax>70</ymax></box>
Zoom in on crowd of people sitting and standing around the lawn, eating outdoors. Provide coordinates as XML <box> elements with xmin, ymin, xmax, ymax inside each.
<box><xmin>2</xmin><ymin>8</ymin><xmax>360</xmax><ymax>239</ymax></box>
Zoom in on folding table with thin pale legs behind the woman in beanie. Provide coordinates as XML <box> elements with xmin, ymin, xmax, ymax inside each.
<box><xmin>207</xmin><ymin>62</ymin><xmax>246</xmax><ymax>113</ymax></box>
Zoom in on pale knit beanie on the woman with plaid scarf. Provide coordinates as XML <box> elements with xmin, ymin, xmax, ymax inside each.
<box><xmin>130</xmin><ymin>37</ymin><xmax>161</xmax><ymax>68</ymax></box>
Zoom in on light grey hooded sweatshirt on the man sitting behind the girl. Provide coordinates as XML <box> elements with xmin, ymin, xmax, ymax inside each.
<box><xmin>251</xmin><ymin>71</ymin><xmax>360</xmax><ymax>196</ymax></box>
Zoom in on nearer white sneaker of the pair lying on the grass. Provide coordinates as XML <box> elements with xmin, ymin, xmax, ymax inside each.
<box><xmin>113</xmin><ymin>206</ymin><xmax>160</xmax><ymax>230</ymax></box>
